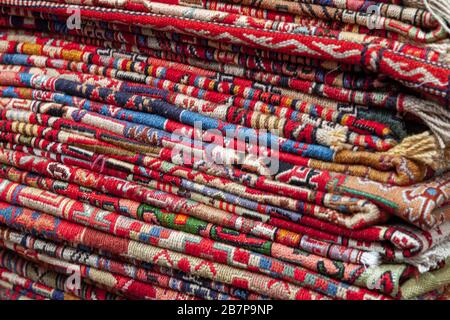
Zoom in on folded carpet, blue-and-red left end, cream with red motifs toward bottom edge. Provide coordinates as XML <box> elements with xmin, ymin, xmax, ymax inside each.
<box><xmin>1</xmin><ymin>203</ymin><xmax>332</xmax><ymax>299</ymax></box>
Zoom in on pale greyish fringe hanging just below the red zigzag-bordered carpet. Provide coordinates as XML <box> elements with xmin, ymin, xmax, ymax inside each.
<box><xmin>402</xmin><ymin>96</ymin><xmax>450</xmax><ymax>149</ymax></box>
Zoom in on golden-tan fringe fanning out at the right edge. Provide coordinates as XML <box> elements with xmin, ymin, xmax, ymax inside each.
<box><xmin>385</xmin><ymin>131</ymin><xmax>450</xmax><ymax>171</ymax></box>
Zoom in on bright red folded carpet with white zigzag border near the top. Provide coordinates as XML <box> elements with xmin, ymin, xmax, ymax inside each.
<box><xmin>1</xmin><ymin>0</ymin><xmax>449</xmax><ymax>96</ymax></box>
